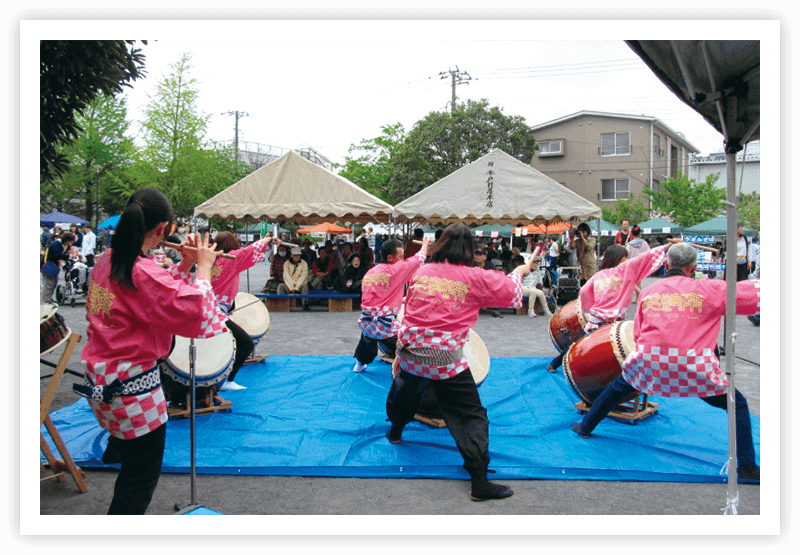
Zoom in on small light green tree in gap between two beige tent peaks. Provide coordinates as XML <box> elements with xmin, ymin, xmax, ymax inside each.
<box><xmin>339</xmin><ymin>123</ymin><xmax>405</xmax><ymax>204</ymax></box>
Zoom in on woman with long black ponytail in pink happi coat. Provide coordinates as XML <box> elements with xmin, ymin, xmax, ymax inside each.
<box><xmin>73</xmin><ymin>188</ymin><xmax>227</xmax><ymax>514</ymax></box>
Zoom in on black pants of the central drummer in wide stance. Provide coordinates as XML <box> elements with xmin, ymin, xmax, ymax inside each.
<box><xmin>386</xmin><ymin>370</ymin><xmax>489</xmax><ymax>471</ymax></box>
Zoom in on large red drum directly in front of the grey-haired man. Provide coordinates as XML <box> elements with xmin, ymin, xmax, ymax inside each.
<box><xmin>563</xmin><ymin>320</ymin><xmax>638</xmax><ymax>405</ymax></box>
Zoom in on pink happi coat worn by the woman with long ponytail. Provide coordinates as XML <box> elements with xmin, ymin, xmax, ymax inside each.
<box><xmin>81</xmin><ymin>250</ymin><xmax>227</xmax><ymax>439</ymax></box>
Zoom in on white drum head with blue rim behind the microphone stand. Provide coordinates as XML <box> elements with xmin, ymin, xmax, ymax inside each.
<box><xmin>167</xmin><ymin>331</ymin><xmax>236</xmax><ymax>385</ymax></box>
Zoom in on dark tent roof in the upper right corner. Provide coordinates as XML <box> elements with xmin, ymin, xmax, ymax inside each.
<box><xmin>626</xmin><ymin>40</ymin><xmax>761</xmax><ymax>151</ymax></box>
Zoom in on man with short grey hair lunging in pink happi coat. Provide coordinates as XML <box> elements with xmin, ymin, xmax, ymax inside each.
<box><xmin>572</xmin><ymin>243</ymin><xmax>761</xmax><ymax>482</ymax></box>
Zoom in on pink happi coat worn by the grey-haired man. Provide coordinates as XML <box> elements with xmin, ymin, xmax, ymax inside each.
<box><xmin>622</xmin><ymin>276</ymin><xmax>761</xmax><ymax>397</ymax></box>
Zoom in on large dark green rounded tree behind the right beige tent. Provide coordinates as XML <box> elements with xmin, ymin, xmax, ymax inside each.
<box><xmin>388</xmin><ymin>99</ymin><xmax>536</xmax><ymax>202</ymax></box>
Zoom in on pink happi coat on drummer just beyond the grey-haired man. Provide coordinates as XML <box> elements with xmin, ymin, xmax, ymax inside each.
<box><xmin>580</xmin><ymin>245</ymin><xmax>667</xmax><ymax>333</ymax></box>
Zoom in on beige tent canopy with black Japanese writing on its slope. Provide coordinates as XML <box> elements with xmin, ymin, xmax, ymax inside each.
<box><xmin>394</xmin><ymin>149</ymin><xmax>601</xmax><ymax>225</ymax></box>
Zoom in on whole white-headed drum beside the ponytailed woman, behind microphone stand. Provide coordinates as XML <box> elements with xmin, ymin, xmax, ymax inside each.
<box><xmin>161</xmin><ymin>331</ymin><xmax>236</xmax><ymax>402</ymax></box>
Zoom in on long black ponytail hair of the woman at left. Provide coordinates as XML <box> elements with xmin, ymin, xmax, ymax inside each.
<box><xmin>110</xmin><ymin>188</ymin><xmax>172</xmax><ymax>290</ymax></box>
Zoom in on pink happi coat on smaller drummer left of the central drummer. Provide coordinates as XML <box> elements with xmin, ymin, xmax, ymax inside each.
<box><xmin>358</xmin><ymin>251</ymin><xmax>426</xmax><ymax>339</ymax></box>
